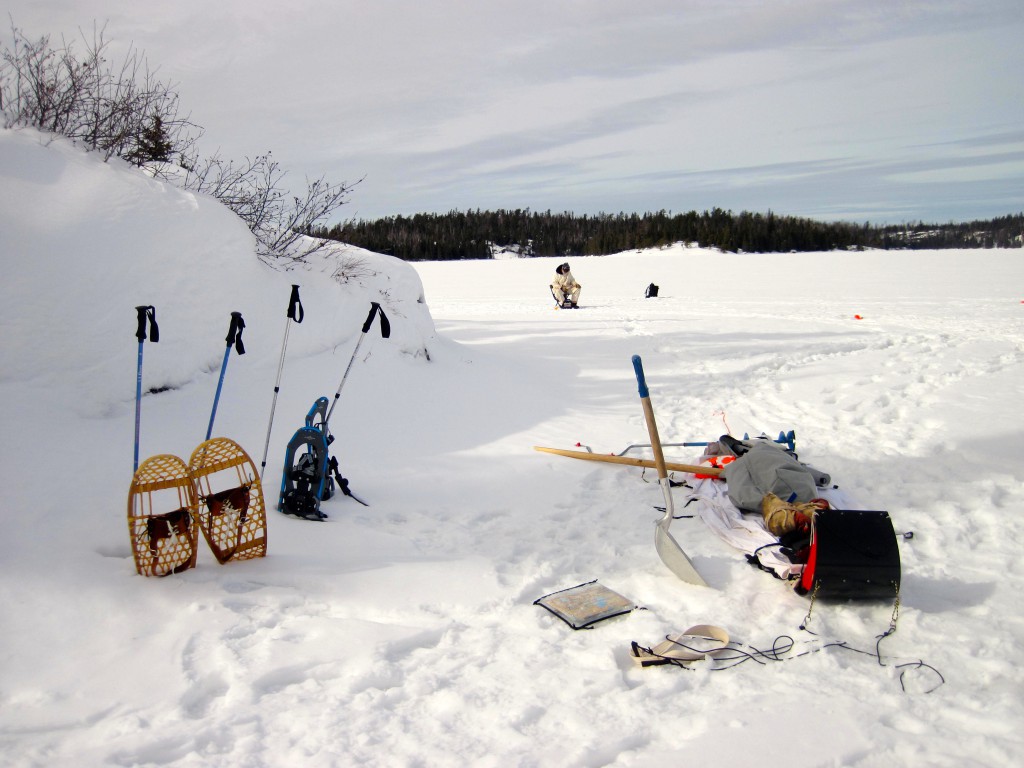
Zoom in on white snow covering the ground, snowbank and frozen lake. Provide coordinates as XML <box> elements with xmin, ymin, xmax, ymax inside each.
<box><xmin>0</xmin><ymin>131</ymin><xmax>1024</xmax><ymax>768</ymax></box>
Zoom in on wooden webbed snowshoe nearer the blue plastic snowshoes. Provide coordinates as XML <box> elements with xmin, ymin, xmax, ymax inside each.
<box><xmin>188</xmin><ymin>437</ymin><xmax>266</xmax><ymax>563</ymax></box>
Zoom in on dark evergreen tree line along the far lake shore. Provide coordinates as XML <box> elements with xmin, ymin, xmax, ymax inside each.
<box><xmin>309</xmin><ymin>208</ymin><xmax>1024</xmax><ymax>261</ymax></box>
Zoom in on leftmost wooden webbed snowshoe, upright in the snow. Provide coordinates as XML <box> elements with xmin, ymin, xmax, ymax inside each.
<box><xmin>128</xmin><ymin>454</ymin><xmax>199</xmax><ymax>577</ymax></box>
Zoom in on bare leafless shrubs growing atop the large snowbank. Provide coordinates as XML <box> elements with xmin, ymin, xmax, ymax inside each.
<box><xmin>0</xmin><ymin>19</ymin><xmax>358</xmax><ymax>262</ymax></box>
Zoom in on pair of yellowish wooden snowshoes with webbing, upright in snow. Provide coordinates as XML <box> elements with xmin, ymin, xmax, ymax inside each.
<box><xmin>128</xmin><ymin>437</ymin><xmax>266</xmax><ymax>577</ymax></box>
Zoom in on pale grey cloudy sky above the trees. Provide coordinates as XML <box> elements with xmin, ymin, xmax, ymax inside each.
<box><xmin>8</xmin><ymin>0</ymin><xmax>1024</xmax><ymax>223</ymax></box>
